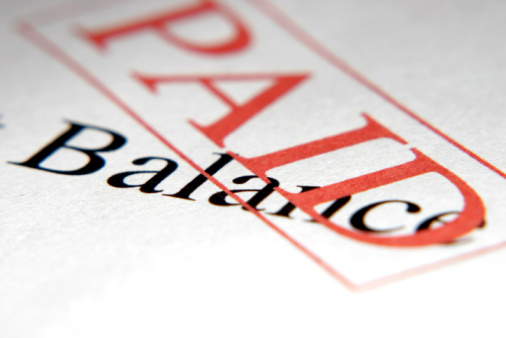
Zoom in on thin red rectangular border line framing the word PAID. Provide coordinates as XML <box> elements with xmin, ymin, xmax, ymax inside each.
<box><xmin>14</xmin><ymin>0</ymin><xmax>506</xmax><ymax>291</ymax></box>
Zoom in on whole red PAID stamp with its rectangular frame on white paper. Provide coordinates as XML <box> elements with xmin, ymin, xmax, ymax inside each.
<box><xmin>23</xmin><ymin>0</ymin><xmax>506</xmax><ymax>289</ymax></box>
